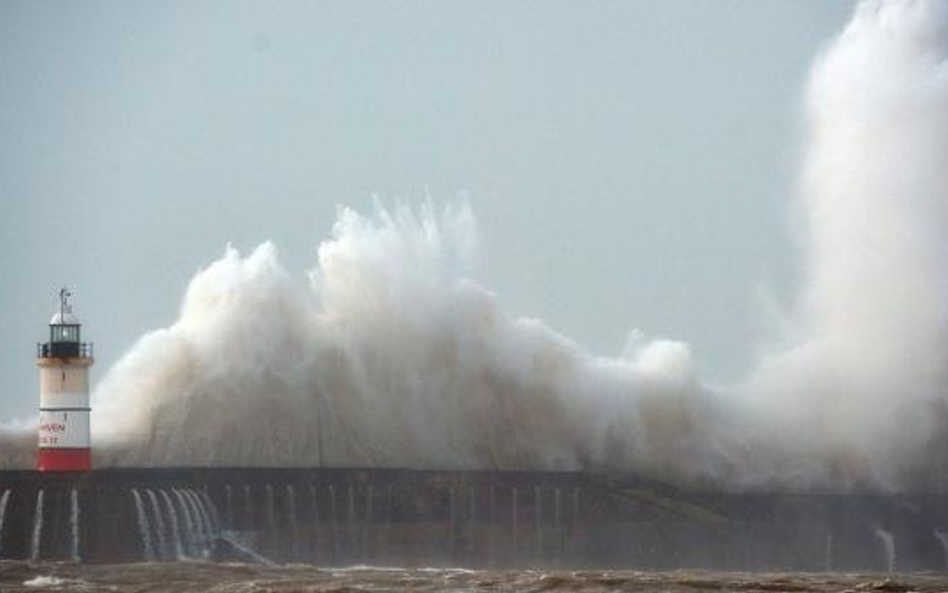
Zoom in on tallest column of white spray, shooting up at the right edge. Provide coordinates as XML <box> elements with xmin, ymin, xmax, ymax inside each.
<box><xmin>744</xmin><ymin>1</ymin><xmax>948</xmax><ymax>485</ymax></box>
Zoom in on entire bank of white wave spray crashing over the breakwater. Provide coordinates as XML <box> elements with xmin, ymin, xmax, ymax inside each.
<box><xmin>0</xmin><ymin>0</ymin><xmax>948</xmax><ymax>487</ymax></box>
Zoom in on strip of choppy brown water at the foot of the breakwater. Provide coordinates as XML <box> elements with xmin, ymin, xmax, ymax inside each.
<box><xmin>0</xmin><ymin>561</ymin><xmax>948</xmax><ymax>593</ymax></box>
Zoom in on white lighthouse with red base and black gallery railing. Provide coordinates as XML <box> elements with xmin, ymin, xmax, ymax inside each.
<box><xmin>36</xmin><ymin>287</ymin><xmax>92</xmax><ymax>471</ymax></box>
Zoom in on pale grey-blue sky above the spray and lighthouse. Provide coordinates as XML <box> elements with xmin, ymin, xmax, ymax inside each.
<box><xmin>0</xmin><ymin>0</ymin><xmax>852</xmax><ymax>421</ymax></box>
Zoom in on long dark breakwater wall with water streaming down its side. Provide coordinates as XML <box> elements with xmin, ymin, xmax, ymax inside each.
<box><xmin>0</xmin><ymin>468</ymin><xmax>948</xmax><ymax>572</ymax></box>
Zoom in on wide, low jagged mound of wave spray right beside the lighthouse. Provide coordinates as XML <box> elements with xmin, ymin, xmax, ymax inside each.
<box><xmin>93</xmin><ymin>205</ymin><xmax>728</xmax><ymax>480</ymax></box>
